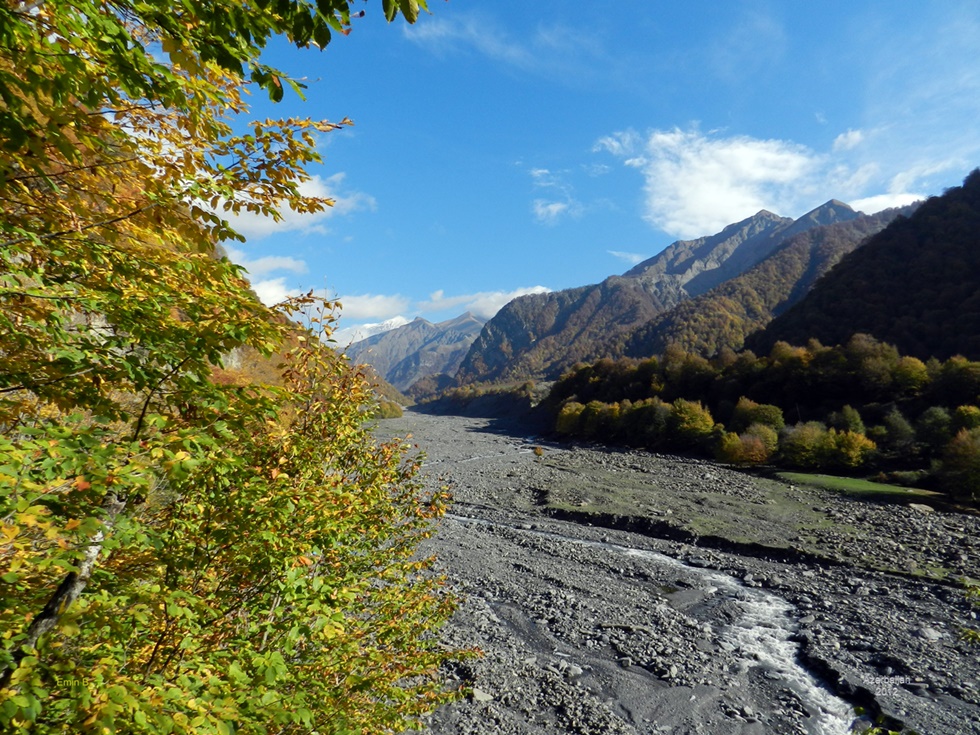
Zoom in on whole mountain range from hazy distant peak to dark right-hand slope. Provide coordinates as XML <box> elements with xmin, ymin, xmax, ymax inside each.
<box><xmin>349</xmin><ymin>172</ymin><xmax>980</xmax><ymax>398</ymax></box>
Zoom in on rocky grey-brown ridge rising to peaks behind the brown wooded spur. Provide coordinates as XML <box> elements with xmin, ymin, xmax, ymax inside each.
<box><xmin>456</xmin><ymin>200</ymin><xmax>859</xmax><ymax>384</ymax></box>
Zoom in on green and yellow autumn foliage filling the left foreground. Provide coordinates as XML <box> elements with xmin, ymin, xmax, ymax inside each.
<box><xmin>0</xmin><ymin>0</ymin><xmax>460</xmax><ymax>733</ymax></box>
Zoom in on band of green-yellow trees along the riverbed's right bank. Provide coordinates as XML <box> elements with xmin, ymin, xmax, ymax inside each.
<box><xmin>546</xmin><ymin>334</ymin><xmax>980</xmax><ymax>500</ymax></box>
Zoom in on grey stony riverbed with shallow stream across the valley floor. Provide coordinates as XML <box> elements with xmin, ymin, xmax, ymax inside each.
<box><xmin>379</xmin><ymin>412</ymin><xmax>980</xmax><ymax>735</ymax></box>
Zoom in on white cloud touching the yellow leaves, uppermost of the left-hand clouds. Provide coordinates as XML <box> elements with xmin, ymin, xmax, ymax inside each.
<box><xmin>225</xmin><ymin>173</ymin><xmax>376</xmax><ymax>240</ymax></box>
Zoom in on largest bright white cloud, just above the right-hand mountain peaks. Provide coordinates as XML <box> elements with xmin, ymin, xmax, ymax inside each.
<box><xmin>593</xmin><ymin>128</ymin><xmax>940</xmax><ymax>238</ymax></box>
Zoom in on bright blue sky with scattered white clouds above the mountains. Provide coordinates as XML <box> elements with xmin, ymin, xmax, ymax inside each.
<box><xmin>231</xmin><ymin>0</ymin><xmax>980</xmax><ymax>342</ymax></box>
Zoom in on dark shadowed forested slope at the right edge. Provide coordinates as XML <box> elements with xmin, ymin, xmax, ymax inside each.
<box><xmin>746</xmin><ymin>170</ymin><xmax>980</xmax><ymax>359</ymax></box>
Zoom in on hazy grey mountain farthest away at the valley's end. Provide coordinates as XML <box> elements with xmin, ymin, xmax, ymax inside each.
<box><xmin>347</xmin><ymin>312</ymin><xmax>485</xmax><ymax>391</ymax></box>
